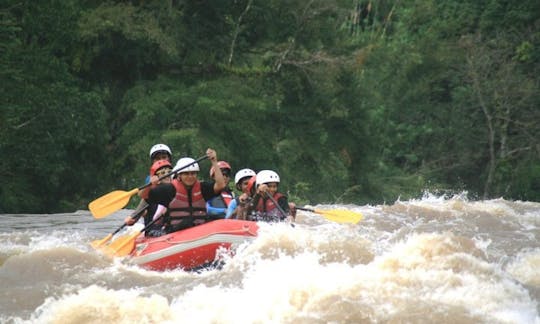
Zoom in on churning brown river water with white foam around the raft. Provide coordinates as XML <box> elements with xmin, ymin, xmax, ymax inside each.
<box><xmin>0</xmin><ymin>195</ymin><xmax>540</xmax><ymax>324</ymax></box>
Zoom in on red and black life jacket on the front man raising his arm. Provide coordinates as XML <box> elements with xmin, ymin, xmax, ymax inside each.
<box><xmin>165</xmin><ymin>179</ymin><xmax>207</xmax><ymax>233</ymax></box>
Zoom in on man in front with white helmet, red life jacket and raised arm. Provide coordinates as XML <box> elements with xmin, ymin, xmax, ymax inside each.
<box><xmin>143</xmin><ymin>148</ymin><xmax>226</xmax><ymax>233</ymax></box>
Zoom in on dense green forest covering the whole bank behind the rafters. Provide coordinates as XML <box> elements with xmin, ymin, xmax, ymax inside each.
<box><xmin>0</xmin><ymin>0</ymin><xmax>540</xmax><ymax>213</ymax></box>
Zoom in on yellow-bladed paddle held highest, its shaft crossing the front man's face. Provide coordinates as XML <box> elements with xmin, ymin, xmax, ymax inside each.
<box><xmin>88</xmin><ymin>155</ymin><xmax>208</xmax><ymax>218</ymax></box>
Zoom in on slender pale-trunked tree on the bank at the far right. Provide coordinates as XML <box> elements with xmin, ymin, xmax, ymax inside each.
<box><xmin>462</xmin><ymin>34</ymin><xmax>540</xmax><ymax>198</ymax></box>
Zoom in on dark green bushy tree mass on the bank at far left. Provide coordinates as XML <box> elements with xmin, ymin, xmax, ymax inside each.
<box><xmin>0</xmin><ymin>1</ymin><xmax>106</xmax><ymax>212</ymax></box>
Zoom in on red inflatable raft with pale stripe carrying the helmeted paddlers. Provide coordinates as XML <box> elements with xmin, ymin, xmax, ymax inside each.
<box><xmin>131</xmin><ymin>219</ymin><xmax>258</xmax><ymax>271</ymax></box>
